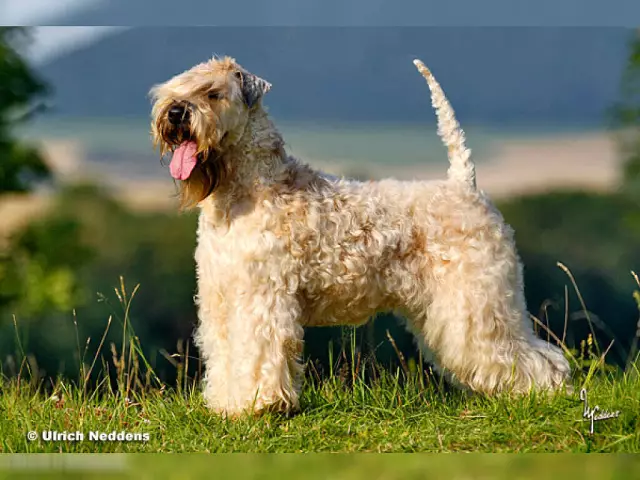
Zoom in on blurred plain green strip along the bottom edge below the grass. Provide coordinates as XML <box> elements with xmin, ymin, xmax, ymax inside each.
<box><xmin>0</xmin><ymin>454</ymin><xmax>640</xmax><ymax>480</ymax></box>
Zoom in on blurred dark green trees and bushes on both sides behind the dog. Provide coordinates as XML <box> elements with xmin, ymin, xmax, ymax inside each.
<box><xmin>0</xmin><ymin>28</ymin><xmax>640</xmax><ymax>381</ymax></box>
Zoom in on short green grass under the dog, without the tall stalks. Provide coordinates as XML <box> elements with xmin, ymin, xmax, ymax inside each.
<box><xmin>0</xmin><ymin>362</ymin><xmax>640</xmax><ymax>452</ymax></box>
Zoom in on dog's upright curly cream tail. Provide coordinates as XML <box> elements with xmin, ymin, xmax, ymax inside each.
<box><xmin>413</xmin><ymin>59</ymin><xmax>476</xmax><ymax>189</ymax></box>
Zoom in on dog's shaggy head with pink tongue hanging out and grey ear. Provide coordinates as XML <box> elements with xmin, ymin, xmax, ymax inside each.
<box><xmin>150</xmin><ymin>57</ymin><xmax>271</xmax><ymax>207</ymax></box>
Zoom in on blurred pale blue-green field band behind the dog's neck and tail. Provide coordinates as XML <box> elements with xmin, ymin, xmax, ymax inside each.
<box><xmin>17</xmin><ymin>117</ymin><xmax>601</xmax><ymax>165</ymax></box>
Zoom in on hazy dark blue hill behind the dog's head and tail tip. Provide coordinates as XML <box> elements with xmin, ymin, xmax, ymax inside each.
<box><xmin>40</xmin><ymin>27</ymin><xmax>631</xmax><ymax>125</ymax></box>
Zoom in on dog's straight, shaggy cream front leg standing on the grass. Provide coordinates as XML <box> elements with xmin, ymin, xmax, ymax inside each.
<box><xmin>197</xmin><ymin>277</ymin><xmax>304</xmax><ymax>416</ymax></box>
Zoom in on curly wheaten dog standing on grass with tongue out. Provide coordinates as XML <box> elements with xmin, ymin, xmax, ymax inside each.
<box><xmin>150</xmin><ymin>57</ymin><xmax>570</xmax><ymax>416</ymax></box>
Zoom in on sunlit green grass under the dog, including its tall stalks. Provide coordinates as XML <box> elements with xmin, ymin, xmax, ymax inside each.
<box><xmin>0</xmin><ymin>274</ymin><xmax>640</xmax><ymax>453</ymax></box>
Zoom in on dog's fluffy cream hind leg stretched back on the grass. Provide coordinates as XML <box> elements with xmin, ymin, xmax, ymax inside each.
<box><xmin>410</xmin><ymin>231</ymin><xmax>569</xmax><ymax>394</ymax></box>
